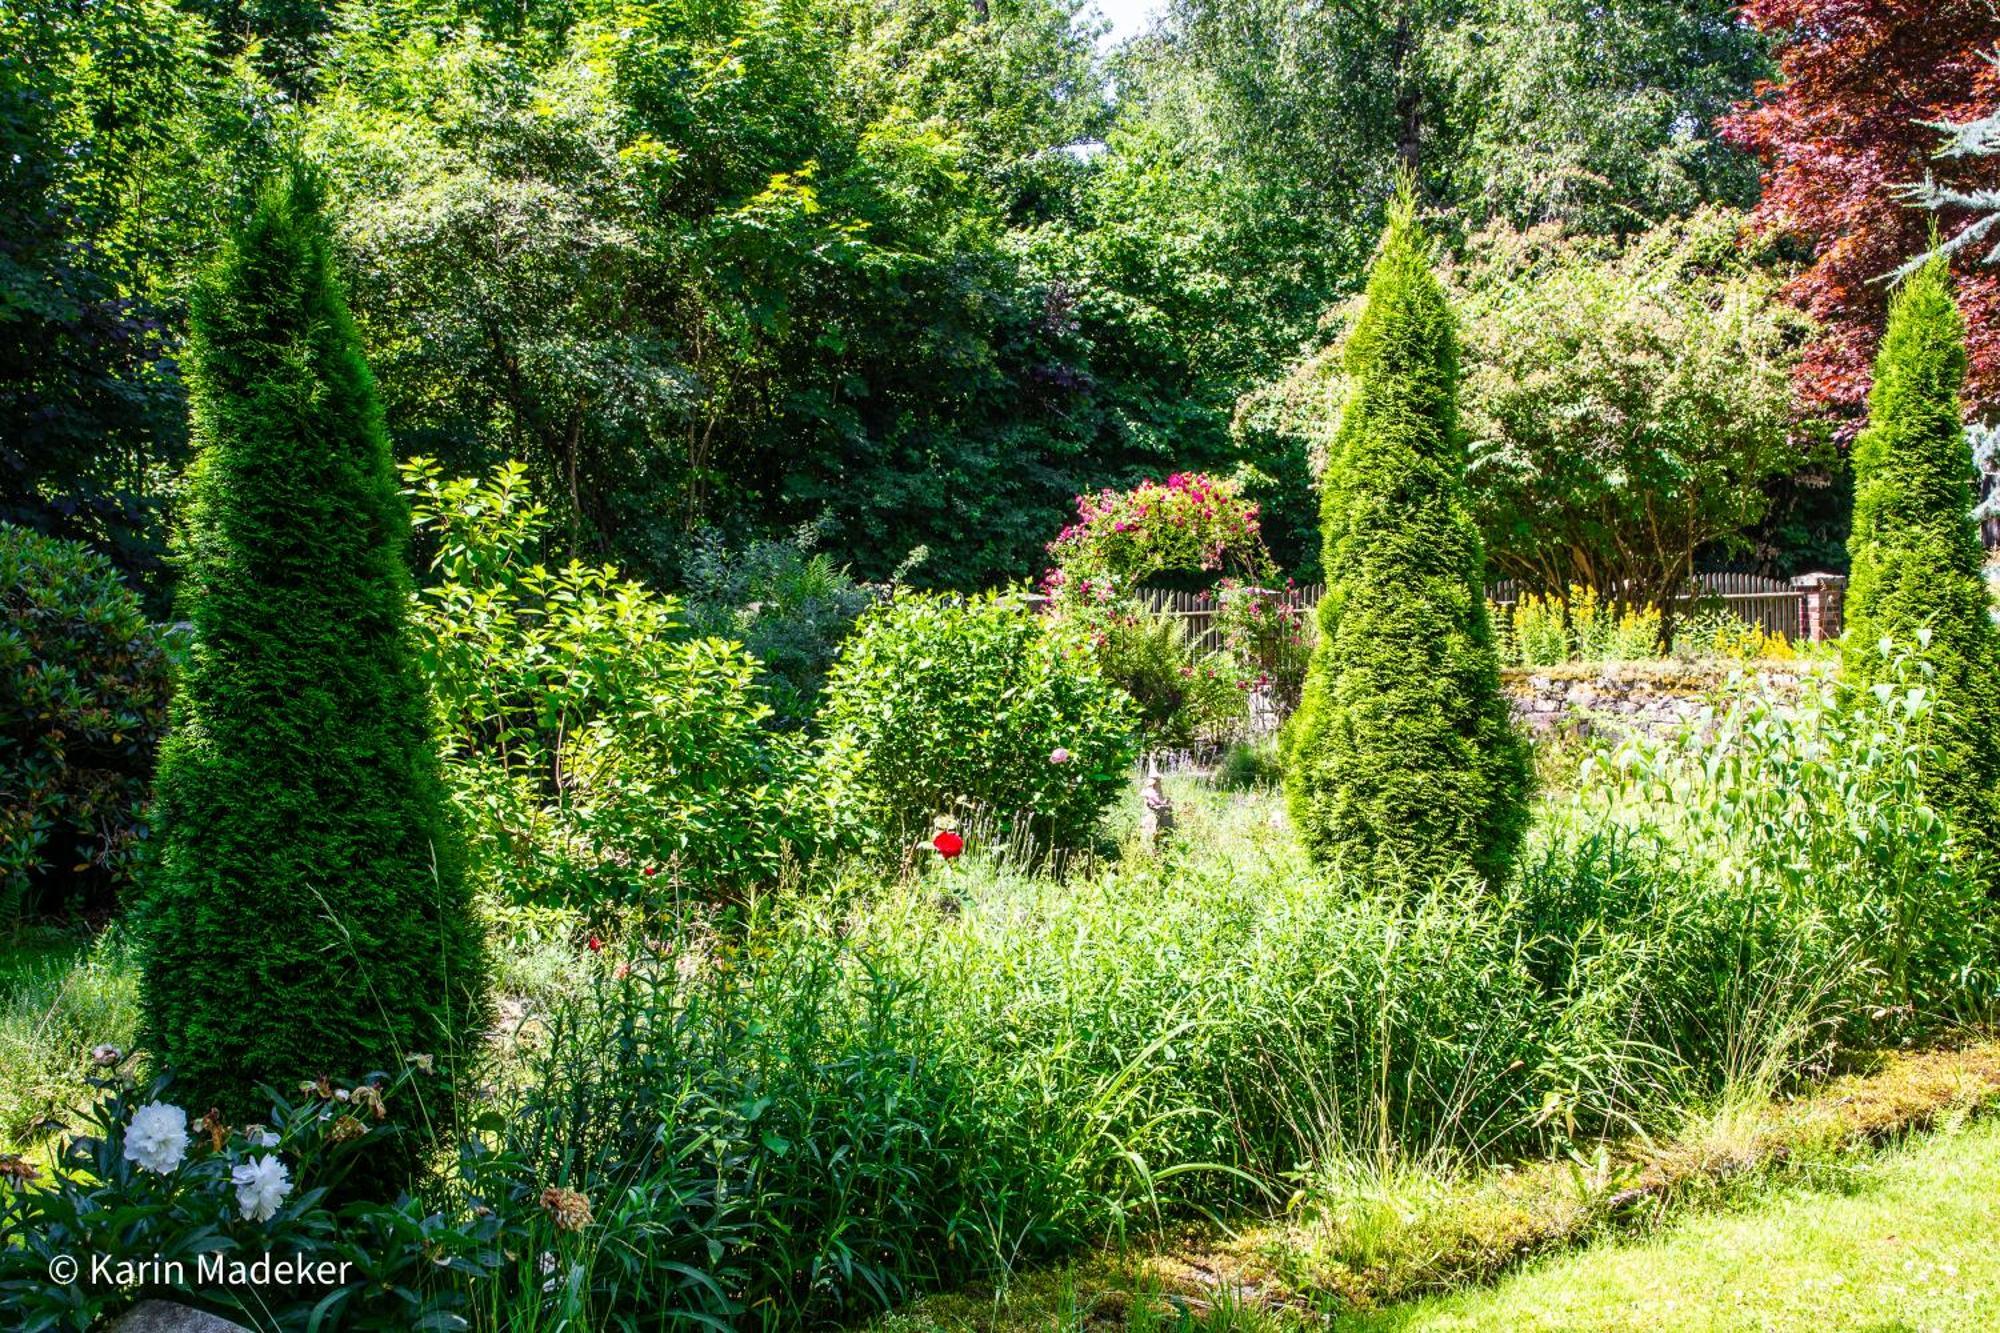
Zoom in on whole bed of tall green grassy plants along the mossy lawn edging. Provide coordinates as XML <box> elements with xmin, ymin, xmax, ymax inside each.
<box><xmin>464</xmin><ymin>660</ymin><xmax>1994</xmax><ymax>1327</ymax></box>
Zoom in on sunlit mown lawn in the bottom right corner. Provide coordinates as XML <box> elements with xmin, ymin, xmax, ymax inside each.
<box><xmin>1338</xmin><ymin>1121</ymin><xmax>2000</xmax><ymax>1331</ymax></box>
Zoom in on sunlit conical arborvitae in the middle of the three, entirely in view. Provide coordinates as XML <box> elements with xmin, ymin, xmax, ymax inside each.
<box><xmin>1286</xmin><ymin>188</ymin><xmax>1532</xmax><ymax>885</ymax></box>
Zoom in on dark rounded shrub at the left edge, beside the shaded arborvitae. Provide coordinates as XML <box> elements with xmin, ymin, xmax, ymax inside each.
<box><xmin>0</xmin><ymin>522</ymin><xmax>168</xmax><ymax>929</ymax></box>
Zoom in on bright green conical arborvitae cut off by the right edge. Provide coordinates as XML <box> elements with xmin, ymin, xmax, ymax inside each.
<box><xmin>1842</xmin><ymin>258</ymin><xmax>2000</xmax><ymax>837</ymax></box>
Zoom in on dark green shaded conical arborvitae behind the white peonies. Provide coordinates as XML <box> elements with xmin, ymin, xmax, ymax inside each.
<box><xmin>140</xmin><ymin>170</ymin><xmax>486</xmax><ymax>1117</ymax></box>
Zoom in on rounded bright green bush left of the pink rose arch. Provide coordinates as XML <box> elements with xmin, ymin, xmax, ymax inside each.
<box><xmin>822</xmin><ymin>592</ymin><xmax>1138</xmax><ymax>847</ymax></box>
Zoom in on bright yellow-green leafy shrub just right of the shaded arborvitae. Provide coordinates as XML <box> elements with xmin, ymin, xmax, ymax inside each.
<box><xmin>404</xmin><ymin>458</ymin><xmax>812</xmax><ymax>907</ymax></box>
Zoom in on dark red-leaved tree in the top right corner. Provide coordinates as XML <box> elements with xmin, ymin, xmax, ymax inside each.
<box><xmin>1722</xmin><ymin>0</ymin><xmax>2000</xmax><ymax>416</ymax></box>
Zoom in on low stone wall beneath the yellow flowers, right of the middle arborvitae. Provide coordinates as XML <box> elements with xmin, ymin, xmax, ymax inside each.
<box><xmin>1500</xmin><ymin>660</ymin><xmax>1822</xmax><ymax>737</ymax></box>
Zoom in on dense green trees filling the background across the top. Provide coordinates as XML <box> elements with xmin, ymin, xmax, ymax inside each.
<box><xmin>0</xmin><ymin>0</ymin><xmax>1920</xmax><ymax>604</ymax></box>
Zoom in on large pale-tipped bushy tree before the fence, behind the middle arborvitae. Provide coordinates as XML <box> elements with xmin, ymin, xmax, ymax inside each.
<box><xmin>1242</xmin><ymin>208</ymin><xmax>1824</xmax><ymax>604</ymax></box>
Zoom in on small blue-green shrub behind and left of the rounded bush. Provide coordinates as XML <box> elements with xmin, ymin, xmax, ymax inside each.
<box><xmin>682</xmin><ymin>526</ymin><xmax>874</xmax><ymax>731</ymax></box>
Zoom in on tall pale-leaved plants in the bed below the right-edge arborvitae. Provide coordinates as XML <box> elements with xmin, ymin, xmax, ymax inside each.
<box><xmin>1516</xmin><ymin>654</ymin><xmax>2000</xmax><ymax>1091</ymax></box>
